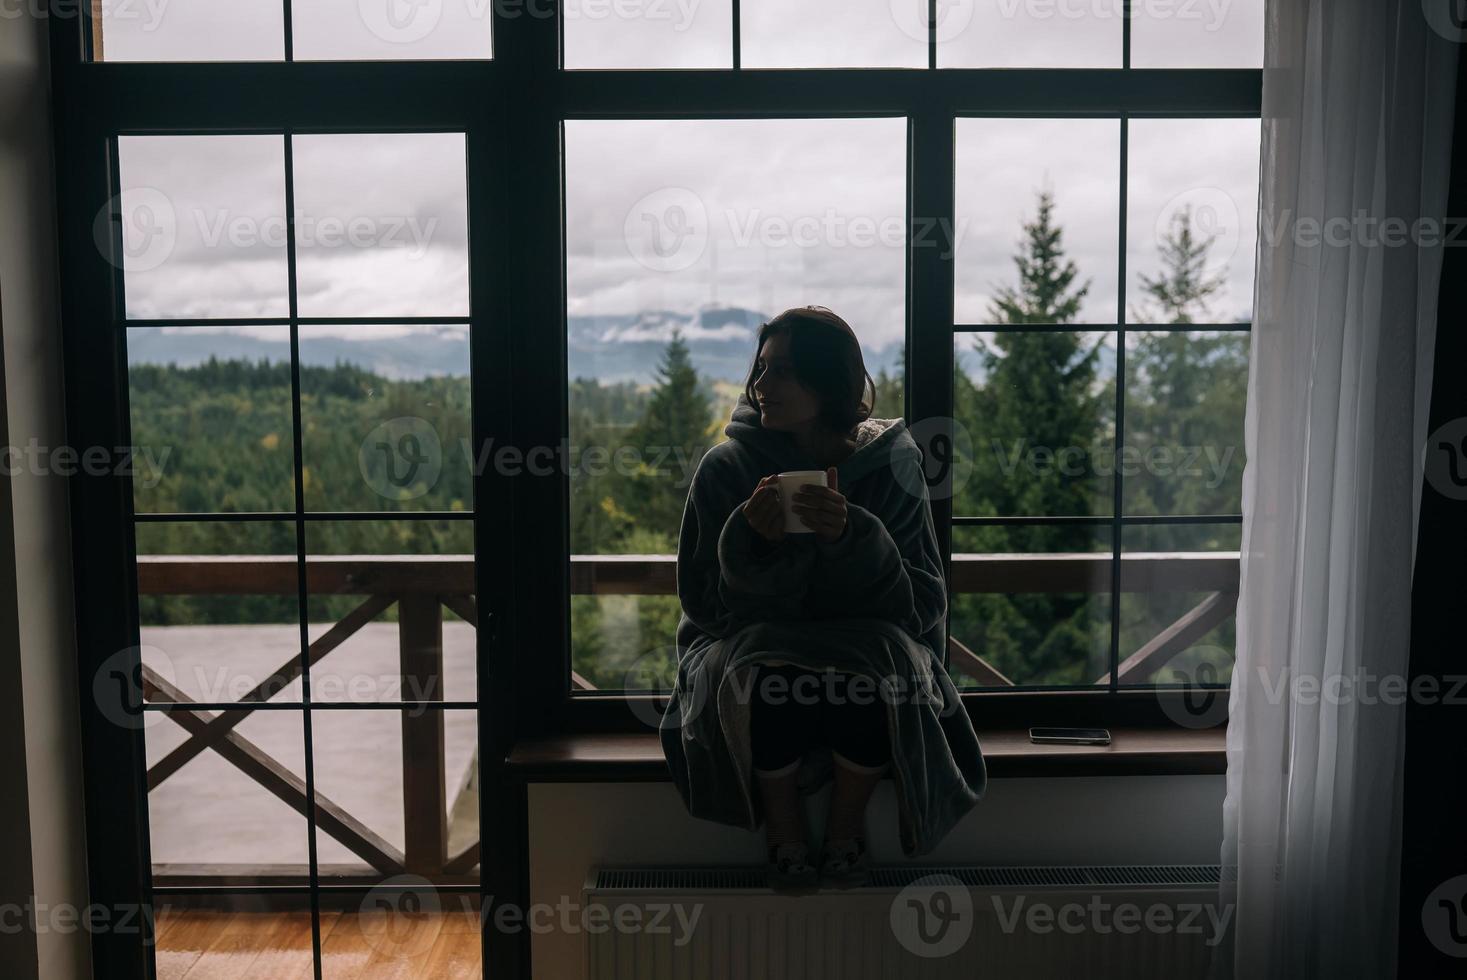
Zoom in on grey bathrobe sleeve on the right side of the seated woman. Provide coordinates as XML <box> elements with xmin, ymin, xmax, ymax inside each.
<box><xmin>811</xmin><ymin>456</ymin><xmax>948</xmax><ymax>638</ymax></box>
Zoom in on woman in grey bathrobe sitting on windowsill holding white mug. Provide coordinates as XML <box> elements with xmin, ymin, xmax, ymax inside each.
<box><xmin>662</xmin><ymin>307</ymin><xmax>986</xmax><ymax>888</ymax></box>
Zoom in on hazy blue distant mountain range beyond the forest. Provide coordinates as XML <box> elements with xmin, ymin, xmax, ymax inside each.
<box><xmin>128</xmin><ymin>307</ymin><xmax>902</xmax><ymax>384</ymax></box>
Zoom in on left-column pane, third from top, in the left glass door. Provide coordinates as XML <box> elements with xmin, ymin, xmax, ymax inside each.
<box><xmin>136</xmin><ymin>521</ymin><xmax>301</xmax><ymax>703</ymax></box>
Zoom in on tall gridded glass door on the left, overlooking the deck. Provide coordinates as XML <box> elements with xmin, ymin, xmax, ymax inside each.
<box><xmin>119</xmin><ymin>132</ymin><xmax>480</xmax><ymax>977</ymax></box>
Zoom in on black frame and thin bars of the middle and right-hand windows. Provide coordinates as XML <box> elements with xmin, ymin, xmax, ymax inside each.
<box><xmin>551</xmin><ymin>82</ymin><xmax>1262</xmax><ymax>735</ymax></box>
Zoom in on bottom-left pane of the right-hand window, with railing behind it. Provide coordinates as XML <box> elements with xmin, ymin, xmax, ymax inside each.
<box><xmin>949</xmin><ymin>524</ymin><xmax>1112</xmax><ymax>690</ymax></box>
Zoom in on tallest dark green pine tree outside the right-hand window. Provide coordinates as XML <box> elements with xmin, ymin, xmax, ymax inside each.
<box><xmin>954</xmin><ymin>189</ymin><xmax>1113</xmax><ymax>684</ymax></box>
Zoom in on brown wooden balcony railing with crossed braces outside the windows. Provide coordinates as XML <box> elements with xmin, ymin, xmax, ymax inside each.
<box><xmin>138</xmin><ymin>553</ymin><xmax>1238</xmax><ymax>883</ymax></box>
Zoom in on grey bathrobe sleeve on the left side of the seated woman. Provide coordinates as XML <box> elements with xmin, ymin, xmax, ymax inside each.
<box><xmin>678</xmin><ymin>458</ymin><xmax>816</xmax><ymax>638</ymax></box>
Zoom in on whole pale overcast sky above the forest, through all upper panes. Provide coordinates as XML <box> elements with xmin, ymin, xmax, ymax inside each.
<box><xmin>107</xmin><ymin>0</ymin><xmax>1260</xmax><ymax>356</ymax></box>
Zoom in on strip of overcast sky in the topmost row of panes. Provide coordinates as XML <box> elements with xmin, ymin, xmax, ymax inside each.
<box><xmin>103</xmin><ymin>0</ymin><xmax>1263</xmax><ymax>67</ymax></box>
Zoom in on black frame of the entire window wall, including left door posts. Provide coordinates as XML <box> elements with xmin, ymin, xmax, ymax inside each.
<box><xmin>50</xmin><ymin>0</ymin><xmax>1263</xmax><ymax>977</ymax></box>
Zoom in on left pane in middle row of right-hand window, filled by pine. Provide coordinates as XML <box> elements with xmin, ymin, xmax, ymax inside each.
<box><xmin>952</xmin><ymin>330</ymin><xmax>1115</xmax><ymax>516</ymax></box>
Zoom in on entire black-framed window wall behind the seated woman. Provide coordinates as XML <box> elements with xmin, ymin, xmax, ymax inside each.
<box><xmin>53</xmin><ymin>0</ymin><xmax>1262</xmax><ymax>976</ymax></box>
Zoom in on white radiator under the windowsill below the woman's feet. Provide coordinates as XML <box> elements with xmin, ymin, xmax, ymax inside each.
<box><xmin>582</xmin><ymin>866</ymin><xmax>1231</xmax><ymax>980</ymax></box>
